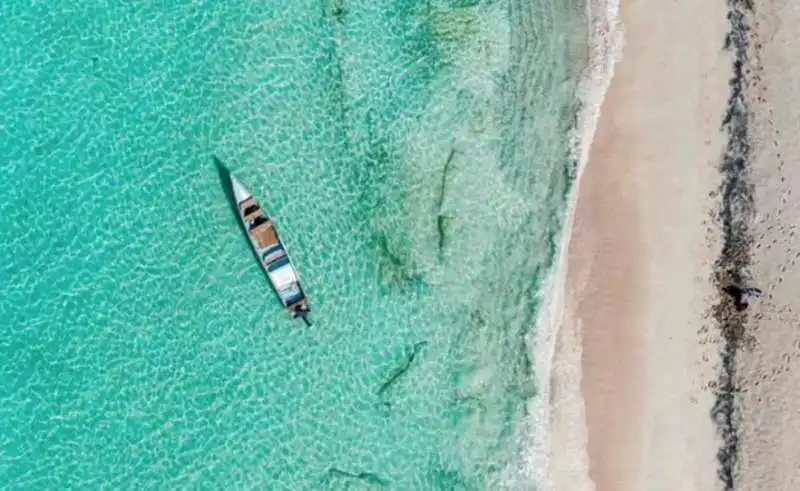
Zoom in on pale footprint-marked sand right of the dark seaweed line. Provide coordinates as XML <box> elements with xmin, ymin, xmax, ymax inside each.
<box><xmin>735</xmin><ymin>1</ymin><xmax>800</xmax><ymax>491</ymax></box>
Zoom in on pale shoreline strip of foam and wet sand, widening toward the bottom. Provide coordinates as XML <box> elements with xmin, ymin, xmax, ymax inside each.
<box><xmin>522</xmin><ymin>0</ymin><xmax>624</xmax><ymax>491</ymax></box>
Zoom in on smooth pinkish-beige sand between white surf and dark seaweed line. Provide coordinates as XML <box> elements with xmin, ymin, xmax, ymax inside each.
<box><xmin>551</xmin><ymin>0</ymin><xmax>731</xmax><ymax>491</ymax></box>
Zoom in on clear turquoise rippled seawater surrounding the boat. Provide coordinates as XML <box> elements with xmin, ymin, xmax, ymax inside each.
<box><xmin>0</xmin><ymin>0</ymin><xmax>578</xmax><ymax>490</ymax></box>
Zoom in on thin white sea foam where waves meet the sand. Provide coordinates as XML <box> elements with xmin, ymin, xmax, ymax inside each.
<box><xmin>509</xmin><ymin>0</ymin><xmax>624</xmax><ymax>490</ymax></box>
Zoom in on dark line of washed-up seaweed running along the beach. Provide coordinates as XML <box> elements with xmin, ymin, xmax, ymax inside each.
<box><xmin>711</xmin><ymin>0</ymin><xmax>753</xmax><ymax>491</ymax></box>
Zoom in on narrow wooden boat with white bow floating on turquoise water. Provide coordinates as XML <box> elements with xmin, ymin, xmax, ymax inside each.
<box><xmin>230</xmin><ymin>174</ymin><xmax>311</xmax><ymax>326</ymax></box>
